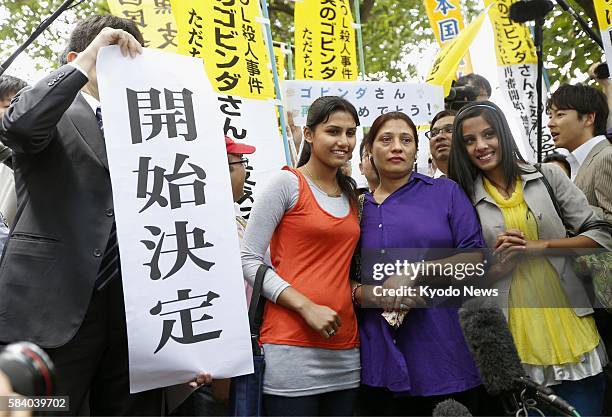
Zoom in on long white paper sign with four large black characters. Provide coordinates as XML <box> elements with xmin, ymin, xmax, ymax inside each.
<box><xmin>97</xmin><ymin>46</ymin><xmax>253</xmax><ymax>392</ymax></box>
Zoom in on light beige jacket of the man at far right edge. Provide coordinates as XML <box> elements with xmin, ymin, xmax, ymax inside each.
<box><xmin>574</xmin><ymin>140</ymin><xmax>612</xmax><ymax>222</ymax></box>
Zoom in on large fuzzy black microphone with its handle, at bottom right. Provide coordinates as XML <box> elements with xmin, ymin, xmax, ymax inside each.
<box><xmin>459</xmin><ymin>298</ymin><xmax>576</xmax><ymax>416</ymax></box>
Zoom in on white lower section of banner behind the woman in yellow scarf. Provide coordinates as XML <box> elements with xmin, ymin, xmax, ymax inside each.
<box><xmin>498</xmin><ymin>64</ymin><xmax>555</xmax><ymax>162</ymax></box>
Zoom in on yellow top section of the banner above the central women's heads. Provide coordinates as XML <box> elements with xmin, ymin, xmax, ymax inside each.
<box><xmin>294</xmin><ymin>0</ymin><xmax>358</xmax><ymax>81</ymax></box>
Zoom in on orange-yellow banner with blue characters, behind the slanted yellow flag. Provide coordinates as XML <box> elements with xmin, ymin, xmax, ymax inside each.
<box><xmin>425</xmin><ymin>0</ymin><xmax>473</xmax><ymax>74</ymax></box>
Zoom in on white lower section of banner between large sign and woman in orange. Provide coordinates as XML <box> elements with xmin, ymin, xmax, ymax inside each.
<box><xmin>217</xmin><ymin>95</ymin><xmax>286</xmax><ymax>220</ymax></box>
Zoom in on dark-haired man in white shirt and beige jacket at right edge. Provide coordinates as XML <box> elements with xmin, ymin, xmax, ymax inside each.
<box><xmin>547</xmin><ymin>85</ymin><xmax>612</xmax><ymax>222</ymax></box>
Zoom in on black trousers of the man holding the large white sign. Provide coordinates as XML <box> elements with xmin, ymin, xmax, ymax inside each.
<box><xmin>45</xmin><ymin>278</ymin><xmax>163</xmax><ymax>416</ymax></box>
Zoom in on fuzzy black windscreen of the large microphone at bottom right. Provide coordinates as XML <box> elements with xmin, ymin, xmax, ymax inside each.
<box><xmin>459</xmin><ymin>298</ymin><xmax>525</xmax><ymax>395</ymax></box>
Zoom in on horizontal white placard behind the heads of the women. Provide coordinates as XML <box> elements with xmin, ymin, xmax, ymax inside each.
<box><xmin>283</xmin><ymin>80</ymin><xmax>444</xmax><ymax>127</ymax></box>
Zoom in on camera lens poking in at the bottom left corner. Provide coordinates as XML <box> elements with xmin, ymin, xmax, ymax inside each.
<box><xmin>0</xmin><ymin>342</ymin><xmax>55</xmax><ymax>397</ymax></box>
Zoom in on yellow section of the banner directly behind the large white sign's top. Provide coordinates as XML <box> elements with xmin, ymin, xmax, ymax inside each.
<box><xmin>171</xmin><ymin>0</ymin><xmax>275</xmax><ymax>99</ymax></box>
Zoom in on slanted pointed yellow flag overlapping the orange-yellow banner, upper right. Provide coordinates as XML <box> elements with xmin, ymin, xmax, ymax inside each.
<box><xmin>425</xmin><ymin>10</ymin><xmax>487</xmax><ymax>96</ymax></box>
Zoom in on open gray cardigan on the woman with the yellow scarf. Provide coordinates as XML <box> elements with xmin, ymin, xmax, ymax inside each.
<box><xmin>472</xmin><ymin>164</ymin><xmax>612</xmax><ymax>316</ymax></box>
